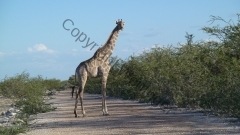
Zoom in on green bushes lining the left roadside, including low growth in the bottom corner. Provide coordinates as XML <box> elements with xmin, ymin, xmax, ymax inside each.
<box><xmin>0</xmin><ymin>72</ymin><xmax>63</xmax><ymax>135</ymax></box>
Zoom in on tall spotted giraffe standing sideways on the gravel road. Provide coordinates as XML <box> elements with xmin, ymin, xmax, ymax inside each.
<box><xmin>74</xmin><ymin>19</ymin><xmax>125</xmax><ymax>117</ymax></box>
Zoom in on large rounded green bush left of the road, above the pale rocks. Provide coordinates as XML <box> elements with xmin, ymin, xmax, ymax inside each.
<box><xmin>0</xmin><ymin>72</ymin><xmax>52</xmax><ymax>115</ymax></box>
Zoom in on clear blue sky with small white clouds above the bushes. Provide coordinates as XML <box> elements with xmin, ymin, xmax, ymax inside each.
<box><xmin>0</xmin><ymin>0</ymin><xmax>240</xmax><ymax>80</ymax></box>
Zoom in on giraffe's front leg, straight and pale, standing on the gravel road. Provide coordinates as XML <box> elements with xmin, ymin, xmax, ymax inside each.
<box><xmin>102</xmin><ymin>74</ymin><xmax>109</xmax><ymax>116</ymax></box>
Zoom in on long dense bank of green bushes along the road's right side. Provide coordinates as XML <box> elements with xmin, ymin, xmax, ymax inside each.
<box><xmin>86</xmin><ymin>15</ymin><xmax>240</xmax><ymax>118</ymax></box>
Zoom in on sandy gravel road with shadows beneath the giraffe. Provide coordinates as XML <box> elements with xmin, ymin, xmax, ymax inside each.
<box><xmin>21</xmin><ymin>89</ymin><xmax>240</xmax><ymax>135</ymax></box>
